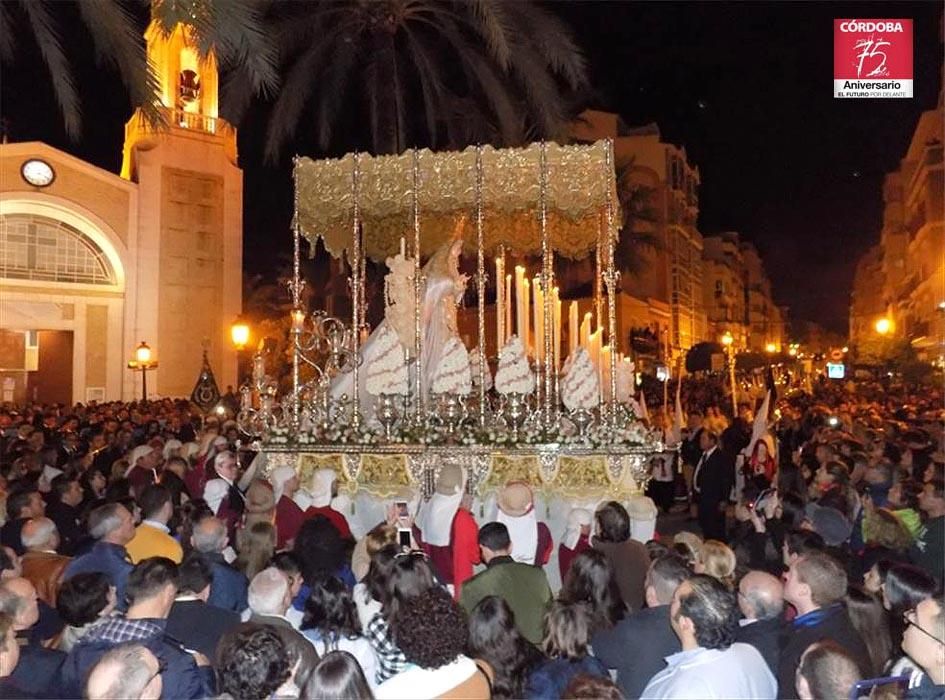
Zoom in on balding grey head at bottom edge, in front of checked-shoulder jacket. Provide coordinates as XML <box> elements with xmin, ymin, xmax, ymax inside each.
<box><xmin>85</xmin><ymin>644</ymin><xmax>163</xmax><ymax>700</ymax></box>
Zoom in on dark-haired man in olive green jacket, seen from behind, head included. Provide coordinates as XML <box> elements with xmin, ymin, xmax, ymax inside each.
<box><xmin>459</xmin><ymin>522</ymin><xmax>551</xmax><ymax>644</ymax></box>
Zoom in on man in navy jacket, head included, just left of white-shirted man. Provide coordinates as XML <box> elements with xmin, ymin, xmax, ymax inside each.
<box><xmin>591</xmin><ymin>554</ymin><xmax>692</xmax><ymax>698</ymax></box>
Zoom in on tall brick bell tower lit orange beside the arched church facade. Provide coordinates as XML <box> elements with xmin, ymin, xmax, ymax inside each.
<box><xmin>121</xmin><ymin>22</ymin><xmax>243</xmax><ymax>397</ymax></box>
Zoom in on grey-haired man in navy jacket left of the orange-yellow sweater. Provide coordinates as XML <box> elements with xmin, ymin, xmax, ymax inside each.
<box><xmin>63</xmin><ymin>503</ymin><xmax>135</xmax><ymax>610</ymax></box>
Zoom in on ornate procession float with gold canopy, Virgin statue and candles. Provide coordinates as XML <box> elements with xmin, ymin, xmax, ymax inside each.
<box><xmin>238</xmin><ymin>141</ymin><xmax>664</xmax><ymax>548</ymax></box>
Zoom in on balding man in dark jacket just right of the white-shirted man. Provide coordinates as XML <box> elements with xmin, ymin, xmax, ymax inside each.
<box><xmin>735</xmin><ymin>571</ymin><xmax>784</xmax><ymax>675</ymax></box>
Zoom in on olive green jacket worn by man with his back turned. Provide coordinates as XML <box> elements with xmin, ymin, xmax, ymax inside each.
<box><xmin>459</xmin><ymin>557</ymin><xmax>551</xmax><ymax>644</ymax></box>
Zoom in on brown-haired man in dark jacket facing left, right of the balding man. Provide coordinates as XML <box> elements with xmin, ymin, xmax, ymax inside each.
<box><xmin>777</xmin><ymin>552</ymin><xmax>871</xmax><ymax>698</ymax></box>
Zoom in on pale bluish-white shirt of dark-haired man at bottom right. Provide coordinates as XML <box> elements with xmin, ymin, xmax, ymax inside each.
<box><xmin>640</xmin><ymin>642</ymin><xmax>778</xmax><ymax>700</ymax></box>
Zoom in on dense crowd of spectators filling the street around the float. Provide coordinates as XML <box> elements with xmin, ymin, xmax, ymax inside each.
<box><xmin>0</xmin><ymin>386</ymin><xmax>945</xmax><ymax>700</ymax></box>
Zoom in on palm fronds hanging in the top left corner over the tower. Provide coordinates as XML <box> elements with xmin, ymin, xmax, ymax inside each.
<box><xmin>0</xmin><ymin>0</ymin><xmax>278</xmax><ymax>139</ymax></box>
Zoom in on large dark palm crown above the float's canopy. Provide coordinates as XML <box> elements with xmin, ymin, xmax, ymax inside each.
<box><xmin>247</xmin><ymin>0</ymin><xmax>586</xmax><ymax>159</ymax></box>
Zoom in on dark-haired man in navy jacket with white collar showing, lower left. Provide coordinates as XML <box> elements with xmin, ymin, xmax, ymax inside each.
<box><xmin>167</xmin><ymin>552</ymin><xmax>240</xmax><ymax>659</ymax></box>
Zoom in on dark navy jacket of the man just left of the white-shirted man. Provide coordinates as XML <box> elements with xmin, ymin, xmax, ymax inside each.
<box><xmin>591</xmin><ymin>605</ymin><xmax>682</xmax><ymax>698</ymax></box>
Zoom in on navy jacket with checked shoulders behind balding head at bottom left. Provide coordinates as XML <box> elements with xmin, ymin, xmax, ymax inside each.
<box><xmin>62</xmin><ymin>617</ymin><xmax>215</xmax><ymax>700</ymax></box>
